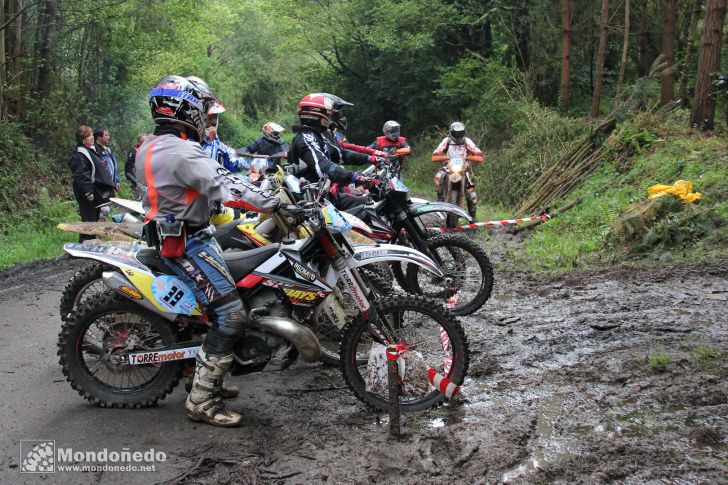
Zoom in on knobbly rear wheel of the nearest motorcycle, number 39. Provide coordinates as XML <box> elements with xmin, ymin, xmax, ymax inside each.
<box><xmin>58</xmin><ymin>291</ymin><xmax>183</xmax><ymax>408</ymax></box>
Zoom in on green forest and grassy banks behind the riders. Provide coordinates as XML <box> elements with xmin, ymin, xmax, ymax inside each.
<box><xmin>0</xmin><ymin>0</ymin><xmax>728</xmax><ymax>268</ymax></box>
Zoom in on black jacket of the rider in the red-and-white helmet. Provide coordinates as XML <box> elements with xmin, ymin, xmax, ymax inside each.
<box><xmin>288</xmin><ymin>126</ymin><xmax>353</xmax><ymax>184</ymax></box>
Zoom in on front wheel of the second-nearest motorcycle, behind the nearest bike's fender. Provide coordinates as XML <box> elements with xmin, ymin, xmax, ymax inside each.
<box><xmin>407</xmin><ymin>234</ymin><xmax>493</xmax><ymax>315</ymax></box>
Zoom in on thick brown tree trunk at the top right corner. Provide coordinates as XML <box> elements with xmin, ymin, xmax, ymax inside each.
<box><xmin>690</xmin><ymin>0</ymin><xmax>726</xmax><ymax>130</ymax></box>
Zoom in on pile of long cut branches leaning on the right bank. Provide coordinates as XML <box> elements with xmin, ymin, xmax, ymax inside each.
<box><xmin>518</xmin><ymin>57</ymin><xmax>666</xmax><ymax>214</ymax></box>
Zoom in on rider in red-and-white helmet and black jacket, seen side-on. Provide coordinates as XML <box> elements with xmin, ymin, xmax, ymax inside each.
<box><xmin>288</xmin><ymin>93</ymin><xmax>372</xmax><ymax>209</ymax></box>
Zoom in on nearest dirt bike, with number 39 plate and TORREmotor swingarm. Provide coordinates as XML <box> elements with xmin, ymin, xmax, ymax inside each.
<box><xmin>58</xmin><ymin>199</ymin><xmax>469</xmax><ymax>411</ymax></box>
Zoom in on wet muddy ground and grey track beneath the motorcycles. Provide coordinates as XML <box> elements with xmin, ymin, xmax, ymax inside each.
<box><xmin>0</xmin><ymin>244</ymin><xmax>728</xmax><ymax>483</ymax></box>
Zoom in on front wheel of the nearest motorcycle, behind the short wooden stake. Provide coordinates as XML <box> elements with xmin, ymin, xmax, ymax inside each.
<box><xmin>341</xmin><ymin>295</ymin><xmax>469</xmax><ymax>412</ymax></box>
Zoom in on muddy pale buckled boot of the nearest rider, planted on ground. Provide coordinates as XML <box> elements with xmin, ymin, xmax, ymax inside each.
<box><xmin>185</xmin><ymin>348</ymin><xmax>241</xmax><ymax>427</ymax></box>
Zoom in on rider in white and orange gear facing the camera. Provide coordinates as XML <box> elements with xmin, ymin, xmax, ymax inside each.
<box><xmin>432</xmin><ymin>121</ymin><xmax>483</xmax><ymax>218</ymax></box>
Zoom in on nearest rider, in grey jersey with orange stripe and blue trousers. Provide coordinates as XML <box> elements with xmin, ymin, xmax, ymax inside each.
<box><xmin>136</xmin><ymin>76</ymin><xmax>295</xmax><ymax>426</ymax></box>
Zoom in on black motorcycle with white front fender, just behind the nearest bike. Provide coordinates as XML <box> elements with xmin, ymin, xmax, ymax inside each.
<box><xmin>324</xmin><ymin>162</ymin><xmax>493</xmax><ymax>315</ymax></box>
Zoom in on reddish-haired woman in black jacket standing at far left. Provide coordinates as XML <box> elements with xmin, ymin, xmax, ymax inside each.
<box><xmin>68</xmin><ymin>125</ymin><xmax>114</xmax><ymax>242</ymax></box>
